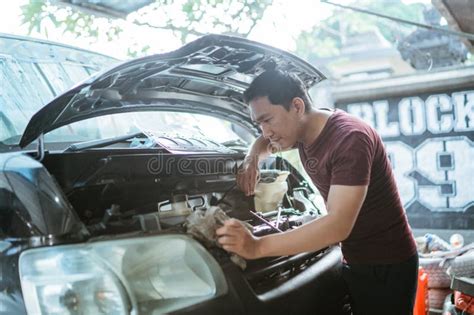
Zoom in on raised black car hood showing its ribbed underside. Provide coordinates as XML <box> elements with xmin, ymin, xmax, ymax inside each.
<box><xmin>20</xmin><ymin>35</ymin><xmax>325</xmax><ymax>147</ymax></box>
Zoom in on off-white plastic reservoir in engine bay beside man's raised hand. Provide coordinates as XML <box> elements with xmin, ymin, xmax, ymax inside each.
<box><xmin>254</xmin><ymin>170</ymin><xmax>290</xmax><ymax>212</ymax></box>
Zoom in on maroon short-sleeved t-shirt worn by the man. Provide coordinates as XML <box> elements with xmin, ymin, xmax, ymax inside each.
<box><xmin>298</xmin><ymin>110</ymin><xmax>416</xmax><ymax>264</ymax></box>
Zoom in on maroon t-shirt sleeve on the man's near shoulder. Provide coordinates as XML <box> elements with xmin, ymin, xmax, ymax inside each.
<box><xmin>331</xmin><ymin>131</ymin><xmax>374</xmax><ymax>186</ymax></box>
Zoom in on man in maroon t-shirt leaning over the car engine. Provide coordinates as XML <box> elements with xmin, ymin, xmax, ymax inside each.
<box><xmin>216</xmin><ymin>70</ymin><xmax>418</xmax><ymax>315</ymax></box>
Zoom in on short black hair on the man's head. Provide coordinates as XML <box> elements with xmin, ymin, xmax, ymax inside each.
<box><xmin>244</xmin><ymin>70</ymin><xmax>311</xmax><ymax>112</ymax></box>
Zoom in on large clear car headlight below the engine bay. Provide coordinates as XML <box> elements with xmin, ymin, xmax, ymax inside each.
<box><xmin>20</xmin><ymin>235</ymin><xmax>227</xmax><ymax>314</ymax></box>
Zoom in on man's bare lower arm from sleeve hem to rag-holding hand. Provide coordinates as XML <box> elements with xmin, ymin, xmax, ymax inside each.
<box><xmin>216</xmin><ymin>185</ymin><xmax>367</xmax><ymax>259</ymax></box>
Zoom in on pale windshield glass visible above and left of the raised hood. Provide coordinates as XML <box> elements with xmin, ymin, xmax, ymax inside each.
<box><xmin>0</xmin><ymin>35</ymin><xmax>117</xmax><ymax>144</ymax></box>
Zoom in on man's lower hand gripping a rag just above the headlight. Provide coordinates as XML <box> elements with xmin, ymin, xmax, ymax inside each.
<box><xmin>216</xmin><ymin>219</ymin><xmax>259</xmax><ymax>259</ymax></box>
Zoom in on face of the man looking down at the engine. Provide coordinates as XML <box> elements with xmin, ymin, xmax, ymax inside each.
<box><xmin>249</xmin><ymin>96</ymin><xmax>304</xmax><ymax>149</ymax></box>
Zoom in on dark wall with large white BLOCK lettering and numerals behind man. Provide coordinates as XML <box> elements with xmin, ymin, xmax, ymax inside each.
<box><xmin>335</xmin><ymin>72</ymin><xmax>474</xmax><ymax>229</ymax></box>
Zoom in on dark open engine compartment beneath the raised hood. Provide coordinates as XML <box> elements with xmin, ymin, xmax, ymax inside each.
<box><xmin>43</xmin><ymin>150</ymin><xmax>321</xmax><ymax>241</ymax></box>
